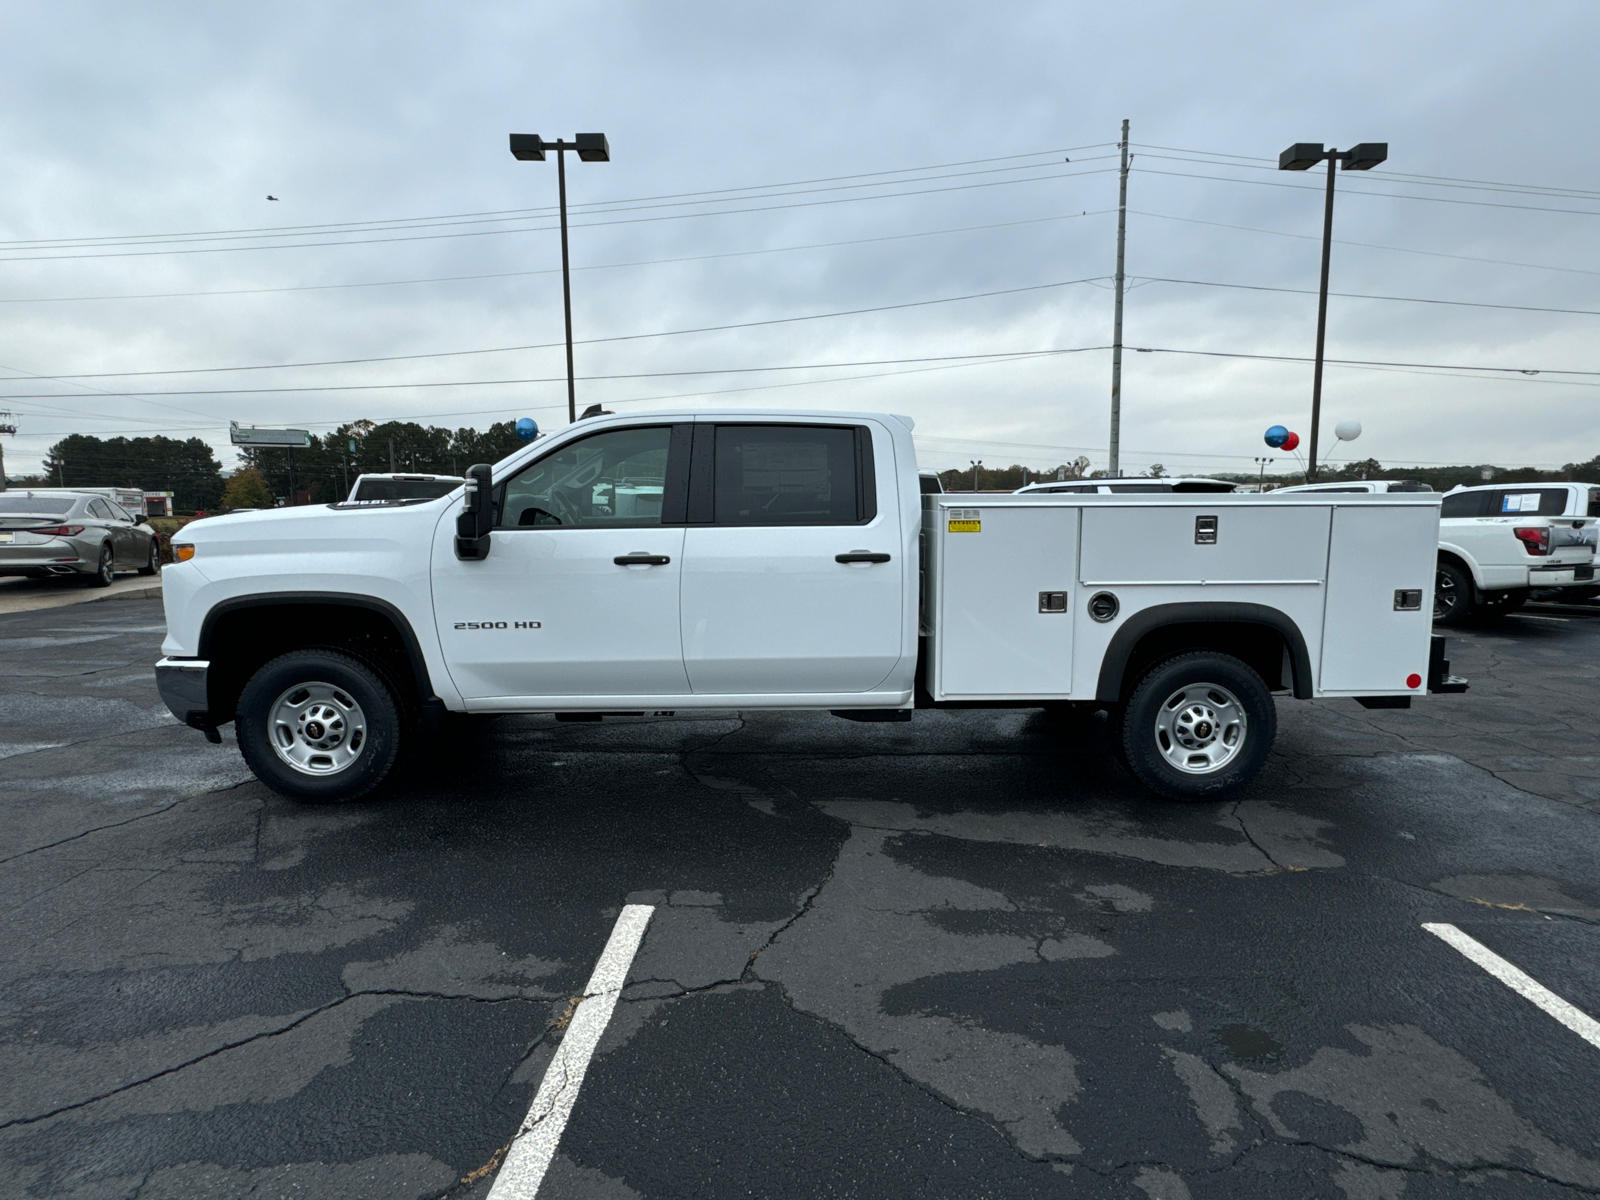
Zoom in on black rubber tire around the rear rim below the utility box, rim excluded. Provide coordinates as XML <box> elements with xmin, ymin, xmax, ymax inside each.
<box><xmin>1117</xmin><ymin>650</ymin><xmax>1278</xmax><ymax>800</ymax></box>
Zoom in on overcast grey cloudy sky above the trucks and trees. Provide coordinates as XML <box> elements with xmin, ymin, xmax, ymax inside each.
<box><xmin>0</xmin><ymin>0</ymin><xmax>1600</xmax><ymax>474</ymax></box>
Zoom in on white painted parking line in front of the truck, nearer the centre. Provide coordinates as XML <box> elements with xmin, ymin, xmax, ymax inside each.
<box><xmin>488</xmin><ymin>904</ymin><xmax>654</xmax><ymax>1200</ymax></box>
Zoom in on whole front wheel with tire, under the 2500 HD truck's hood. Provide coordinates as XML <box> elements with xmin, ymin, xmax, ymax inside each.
<box><xmin>235</xmin><ymin>650</ymin><xmax>400</xmax><ymax>803</ymax></box>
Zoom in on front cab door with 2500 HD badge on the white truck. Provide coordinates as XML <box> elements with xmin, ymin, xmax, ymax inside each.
<box><xmin>434</xmin><ymin>424</ymin><xmax>690</xmax><ymax>701</ymax></box>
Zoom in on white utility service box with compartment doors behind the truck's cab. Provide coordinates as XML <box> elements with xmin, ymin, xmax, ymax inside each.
<box><xmin>923</xmin><ymin>493</ymin><xmax>1438</xmax><ymax>702</ymax></box>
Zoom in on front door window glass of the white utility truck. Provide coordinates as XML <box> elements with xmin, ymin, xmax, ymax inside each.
<box><xmin>496</xmin><ymin>426</ymin><xmax>672</xmax><ymax>530</ymax></box>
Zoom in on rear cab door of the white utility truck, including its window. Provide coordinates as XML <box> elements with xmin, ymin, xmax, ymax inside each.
<box><xmin>682</xmin><ymin>421</ymin><xmax>909</xmax><ymax>696</ymax></box>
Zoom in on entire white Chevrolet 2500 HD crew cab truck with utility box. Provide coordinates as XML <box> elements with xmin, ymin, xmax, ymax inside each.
<box><xmin>155</xmin><ymin>411</ymin><xmax>1466</xmax><ymax>800</ymax></box>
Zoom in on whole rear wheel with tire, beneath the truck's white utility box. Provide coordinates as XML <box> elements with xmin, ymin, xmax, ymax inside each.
<box><xmin>1117</xmin><ymin>650</ymin><xmax>1278</xmax><ymax>800</ymax></box>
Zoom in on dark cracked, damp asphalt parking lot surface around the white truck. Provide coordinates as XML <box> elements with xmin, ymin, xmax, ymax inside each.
<box><xmin>0</xmin><ymin>600</ymin><xmax>1600</xmax><ymax>1200</ymax></box>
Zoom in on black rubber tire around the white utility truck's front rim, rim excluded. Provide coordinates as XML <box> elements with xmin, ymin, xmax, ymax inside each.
<box><xmin>234</xmin><ymin>650</ymin><xmax>403</xmax><ymax>805</ymax></box>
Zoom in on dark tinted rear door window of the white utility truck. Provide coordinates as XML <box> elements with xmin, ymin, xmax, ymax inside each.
<box><xmin>713</xmin><ymin>426</ymin><xmax>877</xmax><ymax>525</ymax></box>
